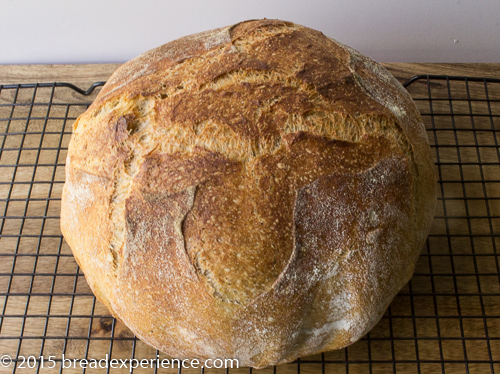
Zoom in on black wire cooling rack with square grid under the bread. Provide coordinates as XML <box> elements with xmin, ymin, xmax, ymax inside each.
<box><xmin>0</xmin><ymin>75</ymin><xmax>500</xmax><ymax>374</ymax></box>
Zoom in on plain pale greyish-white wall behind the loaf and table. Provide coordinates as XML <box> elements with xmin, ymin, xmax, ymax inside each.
<box><xmin>0</xmin><ymin>0</ymin><xmax>500</xmax><ymax>64</ymax></box>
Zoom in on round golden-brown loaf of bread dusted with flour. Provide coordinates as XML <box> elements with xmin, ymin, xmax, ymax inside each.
<box><xmin>61</xmin><ymin>19</ymin><xmax>436</xmax><ymax>368</ymax></box>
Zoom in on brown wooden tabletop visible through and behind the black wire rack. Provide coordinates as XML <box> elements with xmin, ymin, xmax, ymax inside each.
<box><xmin>0</xmin><ymin>63</ymin><xmax>500</xmax><ymax>373</ymax></box>
